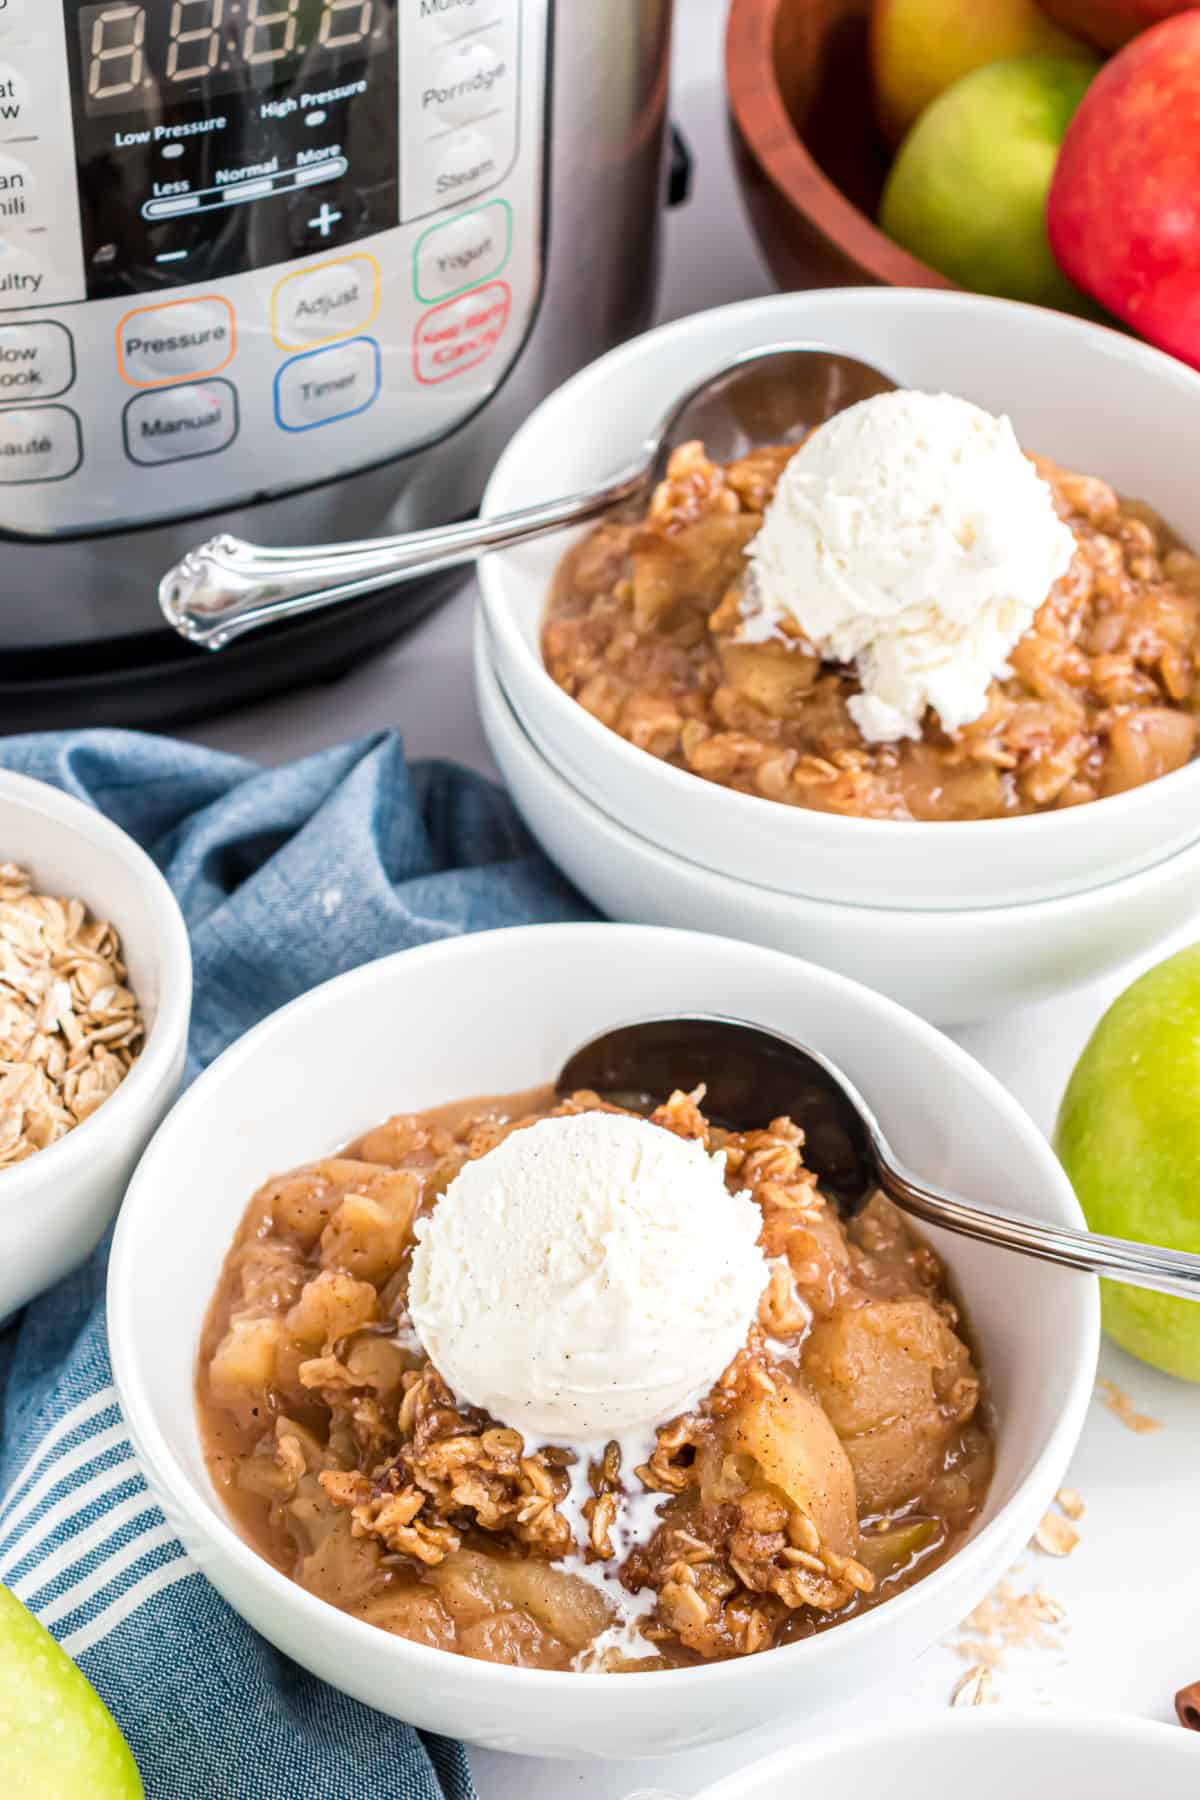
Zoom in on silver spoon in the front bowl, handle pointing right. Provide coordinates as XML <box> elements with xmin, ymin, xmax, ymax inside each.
<box><xmin>554</xmin><ymin>1015</ymin><xmax>1200</xmax><ymax>1300</ymax></box>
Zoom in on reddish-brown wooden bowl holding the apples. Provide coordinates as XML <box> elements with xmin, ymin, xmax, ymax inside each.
<box><xmin>725</xmin><ymin>0</ymin><xmax>955</xmax><ymax>288</ymax></box>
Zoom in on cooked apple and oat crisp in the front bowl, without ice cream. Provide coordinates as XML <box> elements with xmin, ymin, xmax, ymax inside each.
<box><xmin>196</xmin><ymin>1091</ymin><xmax>991</xmax><ymax>1672</ymax></box>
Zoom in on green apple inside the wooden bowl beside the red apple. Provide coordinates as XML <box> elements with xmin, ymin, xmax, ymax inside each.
<box><xmin>880</xmin><ymin>56</ymin><xmax>1097</xmax><ymax>317</ymax></box>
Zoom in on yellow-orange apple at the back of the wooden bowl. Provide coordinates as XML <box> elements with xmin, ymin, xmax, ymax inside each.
<box><xmin>871</xmin><ymin>0</ymin><xmax>1088</xmax><ymax>144</ymax></box>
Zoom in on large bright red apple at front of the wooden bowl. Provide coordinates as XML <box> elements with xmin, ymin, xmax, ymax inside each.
<box><xmin>1045</xmin><ymin>7</ymin><xmax>1200</xmax><ymax>369</ymax></box>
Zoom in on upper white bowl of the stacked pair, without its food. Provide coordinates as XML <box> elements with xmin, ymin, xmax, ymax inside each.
<box><xmin>480</xmin><ymin>288</ymin><xmax>1200</xmax><ymax>909</ymax></box>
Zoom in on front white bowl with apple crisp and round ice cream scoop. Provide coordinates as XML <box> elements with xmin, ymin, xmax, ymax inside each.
<box><xmin>108</xmin><ymin>925</ymin><xmax>1097</xmax><ymax>1757</ymax></box>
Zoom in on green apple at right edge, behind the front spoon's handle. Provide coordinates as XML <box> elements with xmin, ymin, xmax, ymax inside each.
<box><xmin>1056</xmin><ymin>943</ymin><xmax>1200</xmax><ymax>1381</ymax></box>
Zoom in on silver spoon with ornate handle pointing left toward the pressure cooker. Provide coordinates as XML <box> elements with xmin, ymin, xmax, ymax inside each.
<box><xmin>158</xmin><ymin>344</ymin><xmax>896</xmax><ymax>650</ymax></box>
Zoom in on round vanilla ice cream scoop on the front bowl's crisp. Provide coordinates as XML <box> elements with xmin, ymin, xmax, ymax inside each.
<box><xmin>408</xmin><ymin>1112</ymin><xmax>768</xmax><ymax>1444</ymax></box>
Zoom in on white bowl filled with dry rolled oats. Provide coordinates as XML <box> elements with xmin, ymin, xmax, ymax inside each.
<box><xmin>0</xmin><ymin>770</ymin><xmax>193</xmax><ymax>1321</ymax></box>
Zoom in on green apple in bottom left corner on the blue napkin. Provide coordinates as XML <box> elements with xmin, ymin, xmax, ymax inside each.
<box><xmin>0</xmin><ymin>1586</ymin><xmax>144</xmax><ymax>1800</ymax></box>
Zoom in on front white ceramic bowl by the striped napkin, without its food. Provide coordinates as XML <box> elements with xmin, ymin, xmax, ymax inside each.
<box><xmin>108</xmin><ymin>925</ymin><xmax>1097</xmax><ymax>1757</ymax></box>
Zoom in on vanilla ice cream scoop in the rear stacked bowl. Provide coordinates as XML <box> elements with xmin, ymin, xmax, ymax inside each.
<box><xmin>739</xmin><ymin>389</ymin><xmax>1076</xmax><ymax>743</ymax></box>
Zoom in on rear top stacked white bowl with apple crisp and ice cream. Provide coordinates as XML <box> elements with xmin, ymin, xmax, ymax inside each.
<box><xmin>480</xmin><ymin>290</ymin><xmax>1200</xmax><ymax>911</ymax></box>
